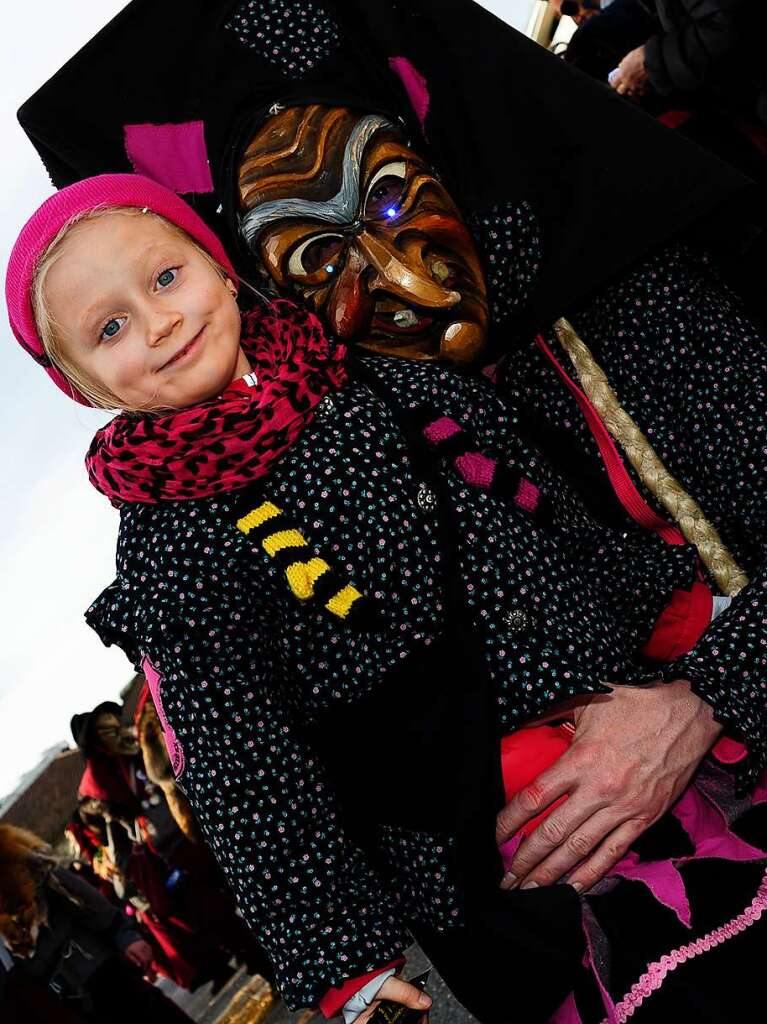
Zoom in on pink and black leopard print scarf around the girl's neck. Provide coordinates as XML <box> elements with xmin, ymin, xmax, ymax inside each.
<box><xmin>85</xmin><ymin>299</ymin><xmax>347</xmax><ymax>507</ymax></box>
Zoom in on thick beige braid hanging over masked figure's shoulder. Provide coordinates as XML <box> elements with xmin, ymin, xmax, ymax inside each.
<box><xmin>554</xmin><ymin>317</ymin><xmax>749</xmax><ymax>597</ymax></box>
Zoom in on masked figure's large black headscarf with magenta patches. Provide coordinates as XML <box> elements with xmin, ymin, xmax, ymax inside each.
<box><xmin>19</xmin><ymin>0</ymin><xmax>747</xmax><ymax>326</ymax></box>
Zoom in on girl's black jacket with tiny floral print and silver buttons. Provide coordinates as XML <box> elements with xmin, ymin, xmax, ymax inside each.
<box><xmin>87</xmin><ymin>357</ymin><xmax>696</xmax><ymax>1007</ymax></box>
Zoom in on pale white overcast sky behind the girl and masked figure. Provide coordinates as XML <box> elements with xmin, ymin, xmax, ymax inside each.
<box><xmin>0</xmin><ymin>0</ymin><xmax>534</xmax><ymax>800</ymax></box>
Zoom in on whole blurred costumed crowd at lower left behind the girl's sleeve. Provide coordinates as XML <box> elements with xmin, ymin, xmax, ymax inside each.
<box><xmin>0</xmin><ymin>686</ymin><xmax>271</xmax><ymax>1024</ymax></box>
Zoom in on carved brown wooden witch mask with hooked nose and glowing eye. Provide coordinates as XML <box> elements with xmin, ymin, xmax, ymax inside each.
<box><xmin>239</xmin><ymin>104</ymin><xmax>487</xmax><ymax>362</ymax></box>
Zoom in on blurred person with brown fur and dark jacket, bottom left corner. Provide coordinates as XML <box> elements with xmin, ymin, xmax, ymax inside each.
<box><xmin>0</xmin><ymin>824</ymin><xmax>189</xmax><ymax>1024</ymax></box>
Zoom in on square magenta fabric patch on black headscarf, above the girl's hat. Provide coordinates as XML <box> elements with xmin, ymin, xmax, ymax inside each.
<box><xmin>123</xmin><ymin>121</ymin><xmax>213</xmax><ymax>193</ymax></box>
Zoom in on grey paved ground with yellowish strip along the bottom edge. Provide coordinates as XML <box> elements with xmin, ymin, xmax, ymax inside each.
<box><xmin>158</xmin><ymin>946</ymin><xmax>474</xmax><ymax>1024</ymax></box>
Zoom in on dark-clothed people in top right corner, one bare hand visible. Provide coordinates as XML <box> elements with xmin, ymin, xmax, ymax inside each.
<box><xmin>551</xmin><ymin>0</ymin><xmax>767</xmax><ymax>180</ymax></box>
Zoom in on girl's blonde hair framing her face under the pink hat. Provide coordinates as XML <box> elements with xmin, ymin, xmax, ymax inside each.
<box><xmin>31</xmin><ymin>206</ymin><xmax>229</xmax><ymax>413</ymax></box>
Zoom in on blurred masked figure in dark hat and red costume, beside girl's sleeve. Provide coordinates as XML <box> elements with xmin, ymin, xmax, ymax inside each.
<box><xmin>70</xmin><ymin>700</ymin><xmax>271</xmax><ymax>990</ymax></box>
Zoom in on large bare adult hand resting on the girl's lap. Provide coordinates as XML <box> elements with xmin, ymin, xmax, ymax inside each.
<box><xmin>497</xmin><ymin>679</ymin><xmax>722</xmax><ymax>892</ymax></box>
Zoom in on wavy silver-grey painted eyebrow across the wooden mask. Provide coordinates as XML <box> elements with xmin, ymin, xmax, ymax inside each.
<box><xmin>240</xmin><ymin>114</ymin><xmax>396</xmax><ymax>248</ymax></box>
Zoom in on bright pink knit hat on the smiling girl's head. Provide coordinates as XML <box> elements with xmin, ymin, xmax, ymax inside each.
<box><xmin>5</xmin><ymin>174</ymin><xmax>239</xmax><ymax>406</ymax></box>
